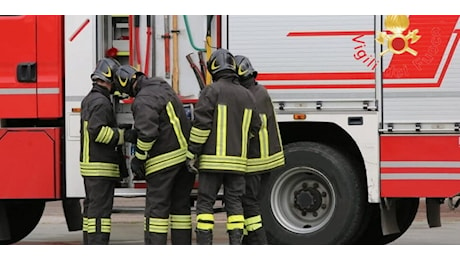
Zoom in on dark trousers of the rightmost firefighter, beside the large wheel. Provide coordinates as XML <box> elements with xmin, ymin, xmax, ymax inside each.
<box><xmin>242</xmin><ymin>173</ymin><xmax>268</xmax><ymax>245</ymax></box>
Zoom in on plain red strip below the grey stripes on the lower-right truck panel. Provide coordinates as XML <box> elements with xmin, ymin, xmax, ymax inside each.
<box><xmin>380</xmin><ymin>180</ymin><xmax>460</xmax><ymax>198</ymax></box>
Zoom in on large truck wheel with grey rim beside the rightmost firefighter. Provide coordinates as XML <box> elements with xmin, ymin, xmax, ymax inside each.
<box><xmin>261</xmin><ymin>142</ymin><xmax>367</xmax><ymax>244</ymax></box>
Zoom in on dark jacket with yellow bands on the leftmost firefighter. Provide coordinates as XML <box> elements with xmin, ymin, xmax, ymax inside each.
<box><xmin>80</xmin><ymin>83</ymin><xmax>124</xmax><ymax>178</ymax></box>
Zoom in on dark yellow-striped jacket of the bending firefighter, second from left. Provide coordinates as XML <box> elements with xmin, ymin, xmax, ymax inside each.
<box><xmin>131</xmin><ymin>76</ymin><xmax>190</xmax><ymax>176</ymax></box>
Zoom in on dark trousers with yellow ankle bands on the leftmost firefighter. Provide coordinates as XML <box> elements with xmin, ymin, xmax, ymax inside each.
<box><xmin>83</xmin><ymin>177</ymin><xmax>118</xmax><ymax>245</ymax></box>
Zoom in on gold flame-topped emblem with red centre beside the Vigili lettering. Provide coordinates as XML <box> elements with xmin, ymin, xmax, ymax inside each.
<box><xmin>375</xmin><ymin>15</ymin><xmax>422</xmax><ymax>56</ymax></box>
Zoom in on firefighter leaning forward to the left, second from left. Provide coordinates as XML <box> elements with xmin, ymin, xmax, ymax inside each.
<box><xmin>116</xmin><ymin>65</ymin><xmax>195</xmax><ymax>245</ymax></box>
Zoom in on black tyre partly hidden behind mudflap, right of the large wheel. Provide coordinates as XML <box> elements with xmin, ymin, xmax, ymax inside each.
<box><xmin>356</xmin><ymin>198</ymin><xmax>420</xmax><ymax>245</ymax></box>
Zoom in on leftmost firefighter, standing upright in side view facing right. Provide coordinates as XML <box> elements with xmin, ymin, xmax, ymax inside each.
<box><xmin>80</xmin><ymin>58</ymin><xmax>134</xmax><ymax>245</ymax></box>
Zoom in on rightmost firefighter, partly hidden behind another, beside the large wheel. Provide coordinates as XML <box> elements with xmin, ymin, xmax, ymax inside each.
<box><xmin>235</xmin><ymin>55</ymin><xmax>284</xmax><ymax>245</ymax></box>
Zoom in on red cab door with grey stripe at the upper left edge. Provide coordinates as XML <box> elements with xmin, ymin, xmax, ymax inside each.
<box><xmin>0</xmin><ymin>15</ymin><xmax>37</xmax><ymax>118</ymax></box>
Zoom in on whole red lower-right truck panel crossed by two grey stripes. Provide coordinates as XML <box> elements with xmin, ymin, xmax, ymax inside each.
<box><xmin>380</xmin><ymin>135</ymin><xmax>460</xmax><ymax>198</ymax></box>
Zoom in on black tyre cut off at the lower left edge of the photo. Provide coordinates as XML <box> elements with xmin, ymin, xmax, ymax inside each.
<box><xmin>0</xmin><ymin>200</ymin><xmax>45</xmax><ymax>245</ymax></box>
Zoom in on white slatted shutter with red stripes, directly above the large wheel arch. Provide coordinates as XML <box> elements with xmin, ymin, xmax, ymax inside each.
<box><xmin>223</xmin><ymin>15</ymin><xmax>377</xmax><ymax>105</ymax></box>
